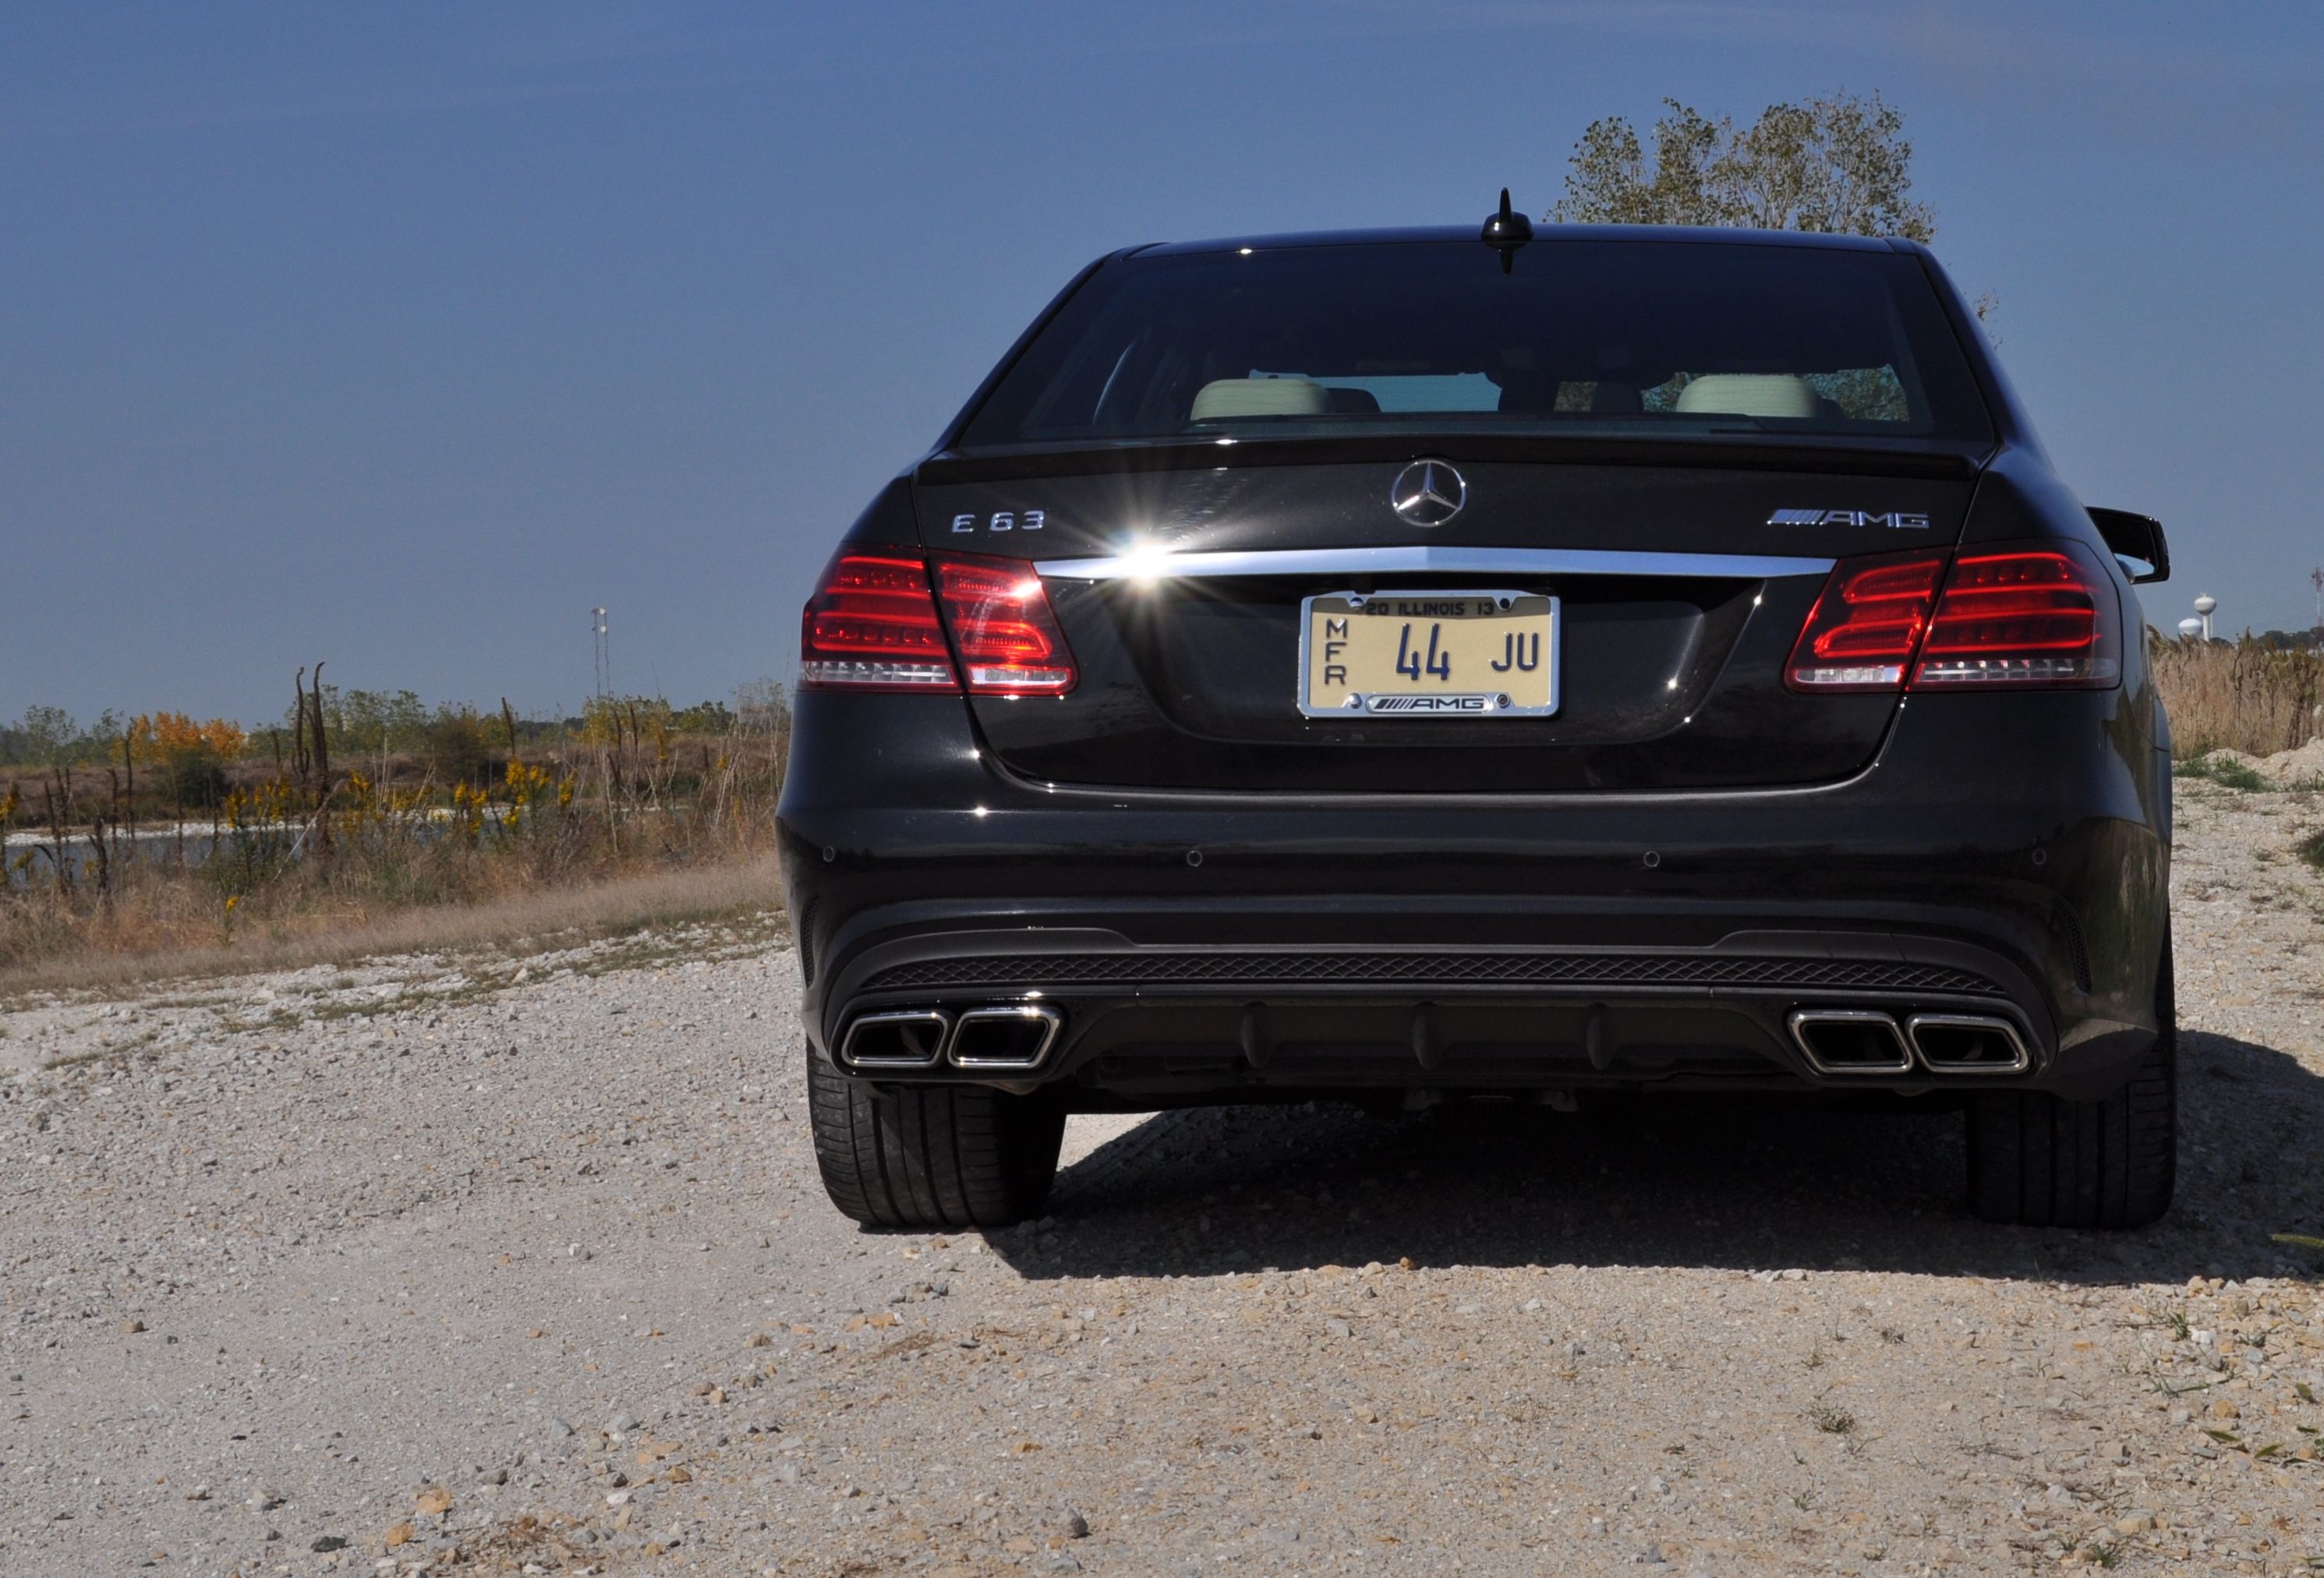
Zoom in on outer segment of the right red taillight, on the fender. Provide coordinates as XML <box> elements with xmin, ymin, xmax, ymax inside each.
<box><xmin>1912</xmin><ymin>542</ymin><xmax>2122</xmax><ymax>690</ymax></box>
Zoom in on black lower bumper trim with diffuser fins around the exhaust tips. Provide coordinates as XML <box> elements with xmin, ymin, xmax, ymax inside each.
<box><xmin>818</xmin><ymin>929</ymin><xmax>2136</xmax><ymax>1097</ymax></box>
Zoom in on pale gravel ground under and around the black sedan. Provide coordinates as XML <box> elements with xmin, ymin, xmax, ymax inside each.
<box><xmin>0</xmin><ymin>784</ymin><xmax>2324</xmax><ymax>1578</ymax></box>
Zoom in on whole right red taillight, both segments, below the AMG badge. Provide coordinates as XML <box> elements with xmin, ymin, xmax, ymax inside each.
<box><xmin>1785</xmin><ymin>542</ymin><xmax>2122</xmax><ymax>692</ymax></box>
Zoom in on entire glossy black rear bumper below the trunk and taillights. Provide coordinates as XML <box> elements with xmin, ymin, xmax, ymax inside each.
<box><xmin>781</xmin><ymin>695</ymin><xmax>2168</xmax><ymax>1106</ymax></box>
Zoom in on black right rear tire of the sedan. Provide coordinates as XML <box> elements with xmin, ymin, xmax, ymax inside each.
<box><xmin>1969</xmin><ymin>939</ymin><xmax>2177</xmax><ymax>1227</ymax></box>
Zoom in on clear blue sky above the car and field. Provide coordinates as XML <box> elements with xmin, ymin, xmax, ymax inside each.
<box><xmin>0</xmin><ymin>0</ymin><xmax>2324</xmax><ymax>718</ymax></box>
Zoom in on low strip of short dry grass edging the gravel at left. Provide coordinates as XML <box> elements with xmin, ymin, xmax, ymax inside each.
<box><xmin>0</xmin><ymin>855</ymin><xmax>781</xmax><ymax>1000</ymax></box>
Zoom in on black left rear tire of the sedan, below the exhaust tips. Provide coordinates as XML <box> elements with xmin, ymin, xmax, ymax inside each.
<box><xmin>806</xmin><ymin>1046</ymin><xmax>1064</xmax><ymax>1229</ymax></box>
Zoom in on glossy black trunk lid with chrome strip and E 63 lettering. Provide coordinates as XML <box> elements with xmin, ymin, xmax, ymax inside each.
<box><xmin>918</xmin><ymin>446</ymin><xmax>1976</xmax><ymax>794</ymax></box>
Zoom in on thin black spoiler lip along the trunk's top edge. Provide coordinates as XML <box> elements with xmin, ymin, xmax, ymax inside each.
<box><xmin>914</xmin><ymin>432</ymin><xmax>1997</xmax><ymax>488</ymax></box>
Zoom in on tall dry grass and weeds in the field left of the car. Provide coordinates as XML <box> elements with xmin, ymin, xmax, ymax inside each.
<box><xmin>0</xmin><ymin>711</ymin><xmax>788</xmax><ymax>990</ymax></box>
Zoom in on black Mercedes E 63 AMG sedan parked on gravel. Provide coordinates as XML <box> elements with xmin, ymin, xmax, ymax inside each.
<box><xmin>781</xmin><ymin>200</ymin><xmax>2175</xmax><ymax>1227</ymax></box>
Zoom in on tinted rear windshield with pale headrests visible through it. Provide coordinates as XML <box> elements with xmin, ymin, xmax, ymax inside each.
<box><xmin>960</xmin><ymin>239</ymin><xmax>1992</xmax><ymax>448</ymax></box>
